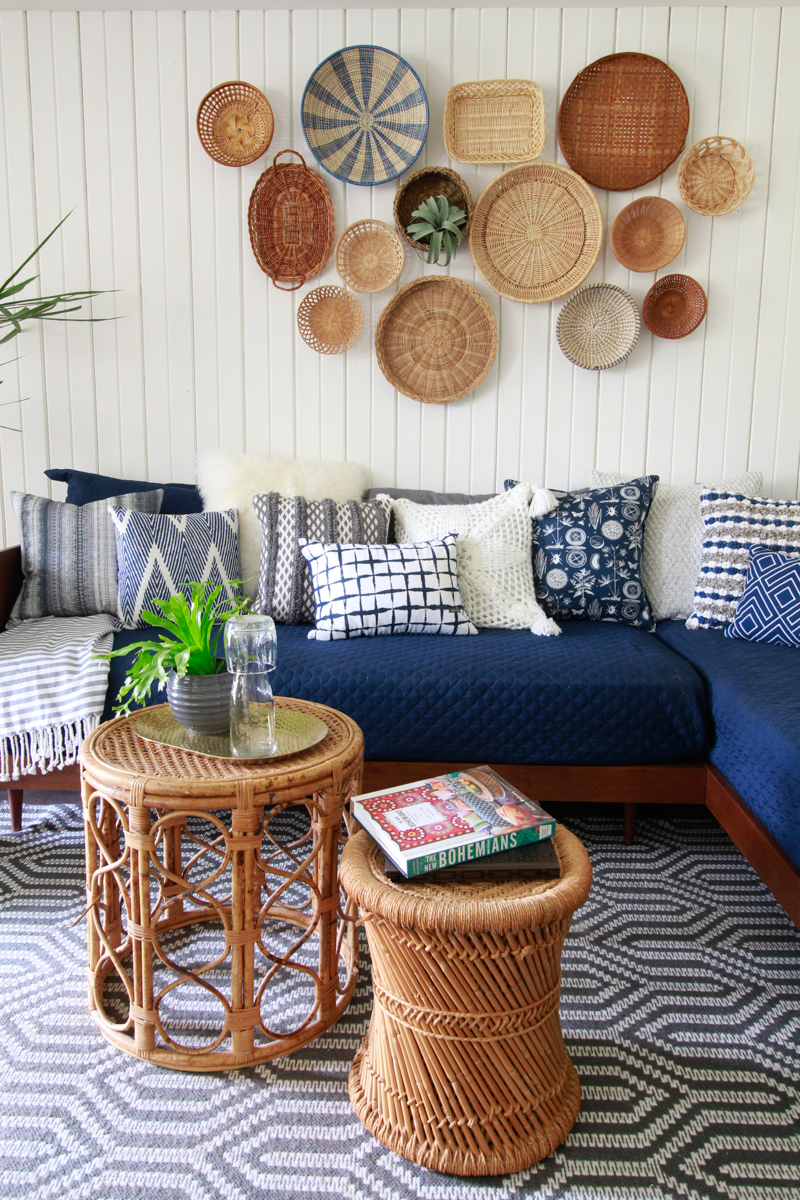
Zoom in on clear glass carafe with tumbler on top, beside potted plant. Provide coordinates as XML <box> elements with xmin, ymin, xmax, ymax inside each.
<box><xmin>225</xmin><ymin>613</ymin><xmax>277</xmax><ymax>758</ymax></box>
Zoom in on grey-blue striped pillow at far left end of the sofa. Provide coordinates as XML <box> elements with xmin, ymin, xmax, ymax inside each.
<box><xmin>8</xmin><ymin>491</ymin><xmax>162</xmax><ymax>626</ymax></box>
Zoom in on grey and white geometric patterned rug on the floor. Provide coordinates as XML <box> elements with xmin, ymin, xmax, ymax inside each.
<box><xmin>0</xmin><ymin>804</ymin><xmax>800</xmax><ymax>1200</ymax></box>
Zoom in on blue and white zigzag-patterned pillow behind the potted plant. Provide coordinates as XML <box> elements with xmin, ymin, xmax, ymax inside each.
<box><xmin>109</xmin><ymin>508</ymin><xmax>241</xmax><ymax>629</ymax></box>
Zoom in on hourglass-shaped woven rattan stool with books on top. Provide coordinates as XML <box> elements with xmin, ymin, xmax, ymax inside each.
<box><xmin>341</xmin><ymin>826</ymin><xmax>591</xmax><ymax>1175</ymax></box>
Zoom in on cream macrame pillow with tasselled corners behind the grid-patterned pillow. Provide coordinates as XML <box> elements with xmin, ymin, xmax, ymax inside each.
<box><xmin>392</xmin><ymin>484</ymin><xmax>561</xmax><ymax>636</ymax></box>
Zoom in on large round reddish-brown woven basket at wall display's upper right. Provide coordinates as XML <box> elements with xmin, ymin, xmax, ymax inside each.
<box><xmin>558</xmin><ymin>53</ymin><xmax>688</xmax><ymax>192</ymax></box>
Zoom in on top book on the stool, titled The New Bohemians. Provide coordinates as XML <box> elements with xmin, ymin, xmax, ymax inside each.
<box><xmin>353</xmin><ymin>767</ymin><xmax>555</xmax><ymax>878</ymax></box>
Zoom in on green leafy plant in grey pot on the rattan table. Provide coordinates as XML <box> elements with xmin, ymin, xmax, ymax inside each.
<box><xmin>98</xmin><ymin>583</ymin><xmax>249</xmax><ymax>734</ymax></box>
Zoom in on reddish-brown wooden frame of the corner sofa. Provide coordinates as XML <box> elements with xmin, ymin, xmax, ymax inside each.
<box><xmin>0</xmin><ymin>546</ymin><xmax>800</xmax><ymax>929</ymax></box>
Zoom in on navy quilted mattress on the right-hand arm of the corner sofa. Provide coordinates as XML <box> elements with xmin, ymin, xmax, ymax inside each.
<box><xmin>657</xmin><ymin>620</ymin><xmax>800</xmax><ymax>868</ymax></box>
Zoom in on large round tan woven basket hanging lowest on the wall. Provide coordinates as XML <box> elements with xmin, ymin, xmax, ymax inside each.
<box><xmin>375</xmin><ymin>275</ymin><xmax>498</xmax><ymax>404</ymax></box>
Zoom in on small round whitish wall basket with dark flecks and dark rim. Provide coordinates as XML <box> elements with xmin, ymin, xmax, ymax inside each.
<box><xmin>555</xmin><ymin>283</ymin><xmax>639</xmax><ymax>371</ymax></box>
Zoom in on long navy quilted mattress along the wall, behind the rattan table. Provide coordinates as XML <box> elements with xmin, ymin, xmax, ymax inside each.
<box><xmin>106</xmin><ymin>622</ymin><xmax>708</xmax><ymax>766</ymax></box>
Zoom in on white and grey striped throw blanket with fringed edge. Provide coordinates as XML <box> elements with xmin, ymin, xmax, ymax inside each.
<box><xmin>0</xmin><ymin>613</ymin><xmax>114</xmax><ymax>781</ymax></box>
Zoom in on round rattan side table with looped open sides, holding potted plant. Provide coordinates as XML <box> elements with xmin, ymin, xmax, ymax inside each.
<box><xmin>80</xmin><ymin>698</ymin><xmax>363</xmax><ymax>1072</ymax></box>
